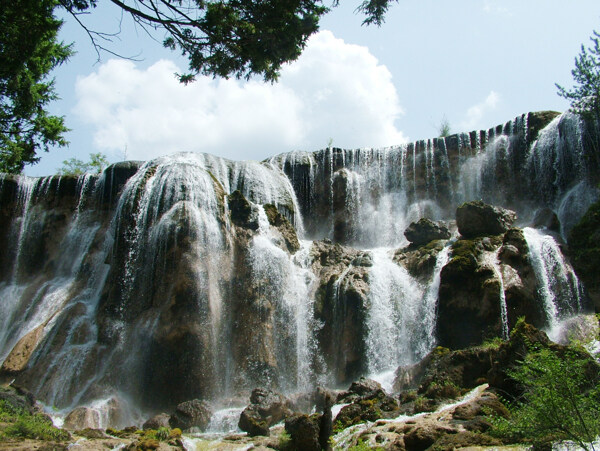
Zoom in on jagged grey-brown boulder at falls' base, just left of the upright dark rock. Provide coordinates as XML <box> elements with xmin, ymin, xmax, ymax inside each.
<box><xmin>238</xmin><ymin>388</ymin><xmax>292</xmax><ymax>436</ymax></box>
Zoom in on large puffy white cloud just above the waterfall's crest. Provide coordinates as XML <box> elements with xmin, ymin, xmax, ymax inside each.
<box><xmin>75</xmin><ymin>31</ymin><xmax>405</xmax><ymax>160</ymax></box>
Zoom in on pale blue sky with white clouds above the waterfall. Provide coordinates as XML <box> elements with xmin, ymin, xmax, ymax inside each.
<box><xmin>25</xmin><ymin>0</ymin><xmax>600</xmax><ymax>176</ymax></box>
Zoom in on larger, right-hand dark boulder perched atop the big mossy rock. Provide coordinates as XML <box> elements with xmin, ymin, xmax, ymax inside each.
<box><xmin>456</xmin><ymin>200</ymin><xmax>517</xmax><ymax>238</ymax></box>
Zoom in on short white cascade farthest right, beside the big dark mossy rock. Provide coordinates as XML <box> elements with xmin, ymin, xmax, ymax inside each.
<box><xmin>523</xmin><ymin>227</ymin><xmax>582</xmax><ymax>339</ymax></box>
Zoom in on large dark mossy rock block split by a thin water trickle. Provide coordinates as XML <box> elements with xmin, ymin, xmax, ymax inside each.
<box><xmin>436</xmin><ymin>224</ymin><xmax>546</xmax><ymax>349</ymax></box>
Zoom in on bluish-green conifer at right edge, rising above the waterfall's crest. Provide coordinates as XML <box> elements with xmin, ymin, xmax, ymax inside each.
<box><xmin>556</xmin><ymin>31</ymin><xmax>600</xmax><ymax>119</ymax></box>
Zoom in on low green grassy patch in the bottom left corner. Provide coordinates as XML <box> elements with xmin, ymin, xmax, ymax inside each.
<box><xmin>0</xmin><ymin>400</ymin><xmax>71</xmax><ymax>441</ymax></box>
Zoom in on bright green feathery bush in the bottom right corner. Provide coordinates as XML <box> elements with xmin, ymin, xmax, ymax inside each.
<box><xmin>492</xmin><ymin>348</ymin><xmax>600</xmax><ymax>449</ymax></box>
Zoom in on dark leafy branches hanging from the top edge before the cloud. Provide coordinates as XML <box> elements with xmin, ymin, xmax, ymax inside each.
<box><xmin>58</xmin><ymin>0</ymin><xmax>397</xmax><ymax>83</ymax></box>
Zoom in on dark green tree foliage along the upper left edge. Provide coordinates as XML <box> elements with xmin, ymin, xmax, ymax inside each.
<box><xmin>0</xmin><ymin>0</ymin><xmax>72</xmax><ymax>173</ymax></box>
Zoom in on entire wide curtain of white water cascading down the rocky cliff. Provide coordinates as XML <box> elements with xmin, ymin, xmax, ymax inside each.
<box><xmin>0</xmin><ymin>114</ymin><xmax>600</xmax><ymax>429</ymax></box>
